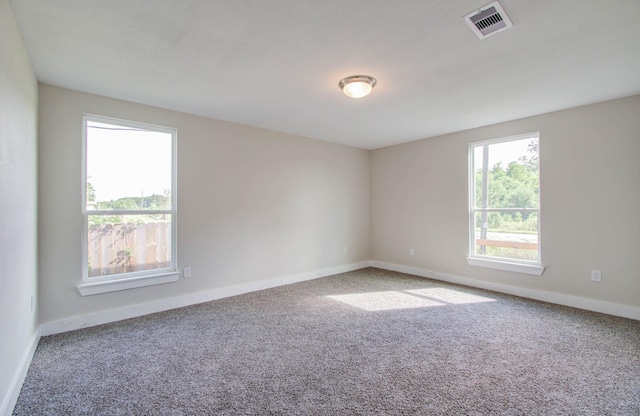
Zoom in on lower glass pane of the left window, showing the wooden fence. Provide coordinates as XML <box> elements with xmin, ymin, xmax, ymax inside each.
<box><xmin>87</xmin><ymin>214</ymin><xmax>171</xmax><ymax>277</ymax></box>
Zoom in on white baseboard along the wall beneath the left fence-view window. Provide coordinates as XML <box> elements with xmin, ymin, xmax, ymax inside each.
<box><xmin>40</xmin><ymin>261</ymin><xmax>369</xmax><ymax>336</ymax></box>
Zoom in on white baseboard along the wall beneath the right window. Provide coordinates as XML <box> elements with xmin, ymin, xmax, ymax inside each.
<box><xmin>369</xmin><ymin>261</ymin><xmax>640</xmax><ymax>320</ymax></box>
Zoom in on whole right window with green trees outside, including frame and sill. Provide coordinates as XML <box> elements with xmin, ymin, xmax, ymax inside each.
<box><xmin>468</xmin><ymin>133</ymin><xmax>544</xmax><ymax>275</ymax></box>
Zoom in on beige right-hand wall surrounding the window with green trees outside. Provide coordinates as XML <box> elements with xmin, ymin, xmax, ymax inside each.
<box><xmin>371</xmin><ymin>96</ymin><xmax>640</xmax><ymax>307</ymax></box>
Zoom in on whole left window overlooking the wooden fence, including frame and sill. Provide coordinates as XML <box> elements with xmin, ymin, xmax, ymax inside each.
<box><xmin>78</xmin><ymin>116</ymin><xmax>179</xmax><ymax>295</ymax></box>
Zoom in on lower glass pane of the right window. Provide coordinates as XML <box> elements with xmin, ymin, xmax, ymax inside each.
<box><xmin>475</xmin><ymin>212</ymin><xmax>538</xmax><ymax>261</ymax></box>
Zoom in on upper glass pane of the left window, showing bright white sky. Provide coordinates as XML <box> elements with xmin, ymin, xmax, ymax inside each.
<box><xmin>86</xmin><ymin>121</ymin><xmax>172</xmax><ymax>211</ymax></box>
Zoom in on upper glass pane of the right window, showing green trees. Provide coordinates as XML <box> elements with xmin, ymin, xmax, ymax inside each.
<box><xmin>473</xmin><ymin>137</ymin><xmax>540</xmax><ymax>208</ymax></box>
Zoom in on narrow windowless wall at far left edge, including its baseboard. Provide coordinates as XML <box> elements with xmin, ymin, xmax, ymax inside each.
<box><xmin>0</xmin><ymin>0</ymin><xmax>38</xmax><ymax>414</ymax></box>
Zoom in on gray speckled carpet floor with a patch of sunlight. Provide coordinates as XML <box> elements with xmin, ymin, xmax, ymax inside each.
<box><xmin>14</xmin><ymin>268</ymin><xmax>640</xmax><ymax>416</ymax></box>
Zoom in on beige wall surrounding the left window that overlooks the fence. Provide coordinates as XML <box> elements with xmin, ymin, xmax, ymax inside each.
<box><xmin>39</xmin><ymin>84</ymin><xmax>370</xmax><ymax>323</ymax></box>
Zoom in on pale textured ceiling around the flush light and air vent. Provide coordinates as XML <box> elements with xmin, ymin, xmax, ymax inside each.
<box><xmin>11</xmin><ymin>0</ymin><xmax>640</xmax><ymax>149</ymax></box>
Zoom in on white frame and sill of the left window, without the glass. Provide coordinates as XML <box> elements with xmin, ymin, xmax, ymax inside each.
<box><xmin>78</xmin><ymin>114</ymin><xmax>180</xmax><ymax>296</ymax></box>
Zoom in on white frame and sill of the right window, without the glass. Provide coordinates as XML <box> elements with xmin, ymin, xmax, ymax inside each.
<box><xmin>467</xmin><ymin>132</ymin><xmax>544</xmax><ymax>276</ymax></box>
